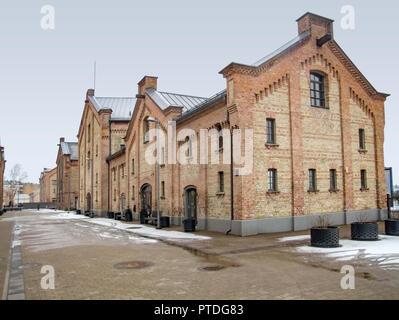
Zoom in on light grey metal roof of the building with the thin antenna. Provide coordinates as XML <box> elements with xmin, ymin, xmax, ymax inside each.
<box><xmin>89</xmin><ymin>96</ymin><xmax>136</xmax><ymax>121</ymax></box>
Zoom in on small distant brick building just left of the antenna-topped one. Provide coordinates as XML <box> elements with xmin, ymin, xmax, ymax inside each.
<box><xmin>57</xmin><ymin>138</ymin><xmax>79</xmax><ymax>210</ymax></box>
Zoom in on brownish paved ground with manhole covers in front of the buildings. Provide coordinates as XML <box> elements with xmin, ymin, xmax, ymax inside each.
<box><xmin>0</xmin><ymin>211</ymin><xmax>399</xmax><ymax>299</ymax></box>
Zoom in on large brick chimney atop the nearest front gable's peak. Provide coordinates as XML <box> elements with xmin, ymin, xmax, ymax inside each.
<box><xmin>296</xmin><ymin>12</ymin><xmax>334</xmax><ymax>38</ymax></box>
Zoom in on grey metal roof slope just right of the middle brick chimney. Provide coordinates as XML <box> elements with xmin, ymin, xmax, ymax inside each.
<box><xmin>146</xmin><ymin>88</ymin><xmax>207</xmax><ymax>113</ymax></box>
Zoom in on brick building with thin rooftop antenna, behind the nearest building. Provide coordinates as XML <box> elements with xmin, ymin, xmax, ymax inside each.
<box><xmin>78</xmin><ymin>89</ymin><xmax>136</xmax><ymax>216</ymax></box>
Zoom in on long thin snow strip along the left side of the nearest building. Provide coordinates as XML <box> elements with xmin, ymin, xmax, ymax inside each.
<box><xmin>43</xmin><ymin>210</ymin><xmax>211</xmax><ymax>241</ymax></box>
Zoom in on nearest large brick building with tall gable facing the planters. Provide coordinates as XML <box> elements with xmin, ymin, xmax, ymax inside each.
<box><xmin>79</xmin><ymin>13</ymin><xmax>388</xmax><ymax>236</ymax></box>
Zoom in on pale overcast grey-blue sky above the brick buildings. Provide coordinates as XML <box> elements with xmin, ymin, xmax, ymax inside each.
<box><xmin>0</xmin><ymin>0</ymin><xmax>399</xmax><ymax>183</ymax></box>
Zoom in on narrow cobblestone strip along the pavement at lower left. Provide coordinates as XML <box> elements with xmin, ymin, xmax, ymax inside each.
<box><xmin>7</xmin><ymin>224</ymin><xmax>25</xmax><ymax>300</ymax></box>
